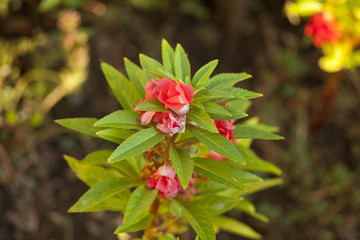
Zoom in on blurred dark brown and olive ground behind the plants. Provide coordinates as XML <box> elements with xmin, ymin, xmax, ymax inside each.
<box><xmin>0</xmin><ymin>0</ymin><xmax>360</xmax><ymax>240</ymax></box>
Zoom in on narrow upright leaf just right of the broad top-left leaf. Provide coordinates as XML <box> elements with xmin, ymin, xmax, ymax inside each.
<box><xmin>124</xmin><ymin>58</ymin><xmax>149</xmax><ymax>99</ymax></box>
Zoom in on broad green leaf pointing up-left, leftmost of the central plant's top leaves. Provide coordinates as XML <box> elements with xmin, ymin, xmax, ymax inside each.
<box><xmin>101</xmin><ymin>63</ymin><xmax>142</xmax><ymax>110</ymax></box>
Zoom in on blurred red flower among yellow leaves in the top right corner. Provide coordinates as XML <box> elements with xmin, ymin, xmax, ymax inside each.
<box><xmin>304</xmin><ymin>13</ymin><xmax>340</xmax><ymax>47</ymax></box>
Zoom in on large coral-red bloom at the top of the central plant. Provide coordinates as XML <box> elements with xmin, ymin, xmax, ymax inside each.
<box><xmin>145</xmin><ymin>78</ymin><xmax>194</xmax><ymax>115</ymax></box>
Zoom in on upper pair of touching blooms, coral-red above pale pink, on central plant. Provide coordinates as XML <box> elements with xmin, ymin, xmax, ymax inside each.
<box><xmin>136</xmin><ymin>78</ymin><xmax>194</xmax><ymax>135</ymax></box>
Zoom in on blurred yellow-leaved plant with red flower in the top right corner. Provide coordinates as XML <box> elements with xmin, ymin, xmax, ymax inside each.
<box><xmin>285</xmin><ymin>0</ymin><xmax>360</xmax><ymax>72</ymax></box>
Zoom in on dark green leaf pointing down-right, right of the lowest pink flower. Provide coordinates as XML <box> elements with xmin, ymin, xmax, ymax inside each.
<box><xmin>193</xmin><ymin>158</ymin><xmax>245</xmax><ymax>190</ymax></box>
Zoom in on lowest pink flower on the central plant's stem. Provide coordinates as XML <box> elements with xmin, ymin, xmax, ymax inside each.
<box><xmin>147</xmin><ymin>165</ymin><xmax>183</xmax><ymax>199</ymax></box>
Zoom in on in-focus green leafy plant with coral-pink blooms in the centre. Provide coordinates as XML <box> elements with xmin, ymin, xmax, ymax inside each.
<box><xmin>57</xmin><ymin>40</ymin><xmax>282</xmax><ymax>240</ymax></box>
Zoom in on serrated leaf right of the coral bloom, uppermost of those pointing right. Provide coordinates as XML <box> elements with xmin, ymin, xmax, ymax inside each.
<box><xmin>206</xmin><ymin>73</ymin><xmax>251</xmax><ymax>90</ymax></box>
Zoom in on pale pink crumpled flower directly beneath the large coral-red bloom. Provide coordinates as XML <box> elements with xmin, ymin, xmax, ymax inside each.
<box><xmin>153</xmin><ymin>111</ymin><xmax>186</xmax><ymax>135</ymax></box>
